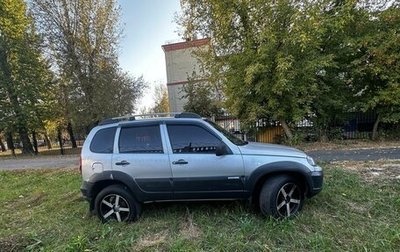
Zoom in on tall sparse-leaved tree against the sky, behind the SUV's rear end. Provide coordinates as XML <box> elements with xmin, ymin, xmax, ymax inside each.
<box><xmin>32</xmin><ymin>0</ymin><xmax>144</xmax><ymax>138</ymax></box>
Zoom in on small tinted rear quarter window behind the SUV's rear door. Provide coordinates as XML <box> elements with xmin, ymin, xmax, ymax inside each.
<box><xmin>90</xmin><ymin>127</ymin><xmax>116</xmax><ymax>153</ymax></box>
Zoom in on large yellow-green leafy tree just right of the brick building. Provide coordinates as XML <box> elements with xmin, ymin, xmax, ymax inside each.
<box><xmin>180</xmin><ymin>0</ymin><xmax>332</xmax><ymax>139</ymax></box>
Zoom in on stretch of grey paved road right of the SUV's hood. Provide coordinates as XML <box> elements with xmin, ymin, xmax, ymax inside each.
<box><xmin>307</xmin><ymin>148</ymin><xmax>400</xmax><ymax>162</ymax></box>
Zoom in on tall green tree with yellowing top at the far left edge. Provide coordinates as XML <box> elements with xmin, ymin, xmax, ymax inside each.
<box><xmin>0</xmin><ymin>0</ymin><xmax>51</xmax><ymax>153</ymax></box>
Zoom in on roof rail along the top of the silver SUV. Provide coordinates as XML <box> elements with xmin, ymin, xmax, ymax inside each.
<box><xmin>98</xmin><ymin>112</ymin><xmax>201</xmax><ymax>125</ymax></box>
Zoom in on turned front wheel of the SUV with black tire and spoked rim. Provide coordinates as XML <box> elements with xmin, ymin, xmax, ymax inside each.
<box><xmin>259</xmin><ymin>175</ymin><xmax>304</xmax><ymax>219</ymax></box>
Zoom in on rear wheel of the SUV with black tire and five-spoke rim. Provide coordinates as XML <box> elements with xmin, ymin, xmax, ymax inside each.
<box><xmin>94</xmin><ymin>185</ymin><xmax>141</xmax><ymax>223</ymax></box>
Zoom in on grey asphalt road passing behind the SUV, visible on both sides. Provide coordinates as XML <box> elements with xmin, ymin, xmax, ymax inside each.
<box><xmin>0</xmin><ymin>148</ymin><xmax>400</xmax><ymax>170</ymax></box>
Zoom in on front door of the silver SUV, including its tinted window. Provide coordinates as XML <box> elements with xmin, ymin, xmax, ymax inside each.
<box><xmin>167</xmin><ymin>123</ymin><xmax>244</xmax><ymax>199</ymax></box>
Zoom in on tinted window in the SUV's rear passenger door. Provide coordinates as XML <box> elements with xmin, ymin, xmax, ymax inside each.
<box><xmin>119</xmin><ymin>125</ymin><xmax>163</xmax><ymax>153</ymax></box>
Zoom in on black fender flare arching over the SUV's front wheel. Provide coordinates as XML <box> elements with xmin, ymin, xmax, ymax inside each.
<box><xmin>246</xmin><ymin>161</ymin><xmax>313</xmax><ymax>194</ymax></box>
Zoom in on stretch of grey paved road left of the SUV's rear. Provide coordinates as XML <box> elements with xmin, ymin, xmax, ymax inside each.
<box><xmin>0</xmin><ymin>155</ymin><xmax>79</xmax><ymax>170</ymax></box>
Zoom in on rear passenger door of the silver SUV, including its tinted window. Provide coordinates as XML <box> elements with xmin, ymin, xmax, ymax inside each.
<box><xmin>113</xmin><ymin>123</ymin><xmax>172</xmax><ymax>200</ymax></box>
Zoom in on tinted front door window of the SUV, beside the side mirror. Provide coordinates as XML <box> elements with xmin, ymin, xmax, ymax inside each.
<box><xmin>168</xmin><ymin>125</ymin><xmax>221</xmax><ymax>153</ymax></box>
